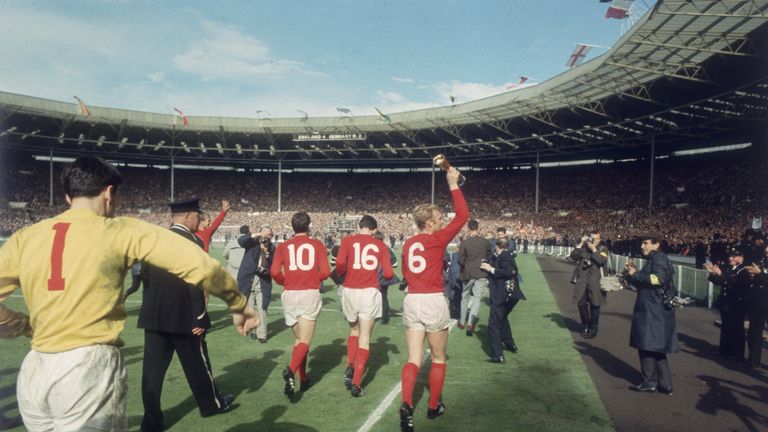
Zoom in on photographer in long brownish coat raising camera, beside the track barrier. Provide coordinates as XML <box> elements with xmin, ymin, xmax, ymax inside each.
<box><xmin>571</xmin><ymin>231</ymin><xmax>608</xmax><ymax>339</ymax></box>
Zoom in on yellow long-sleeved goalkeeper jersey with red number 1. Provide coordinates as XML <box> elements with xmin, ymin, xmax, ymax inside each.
<box><xmin>0</xmin><ymin>209</ymin><xmax>246</xmax><ymax>353</ymax></box>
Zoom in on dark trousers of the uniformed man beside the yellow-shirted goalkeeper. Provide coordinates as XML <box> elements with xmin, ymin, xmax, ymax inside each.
<box><xmin>141</xmin><ymin>330</ymin><xmax>221</xmax><ymax>431</ymax></box>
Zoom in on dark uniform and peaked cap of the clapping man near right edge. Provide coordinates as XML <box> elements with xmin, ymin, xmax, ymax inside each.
<box><xmin>709</xmin><ymin>251</ymin><xmax>751</xmax><ymax>360</ymax></box>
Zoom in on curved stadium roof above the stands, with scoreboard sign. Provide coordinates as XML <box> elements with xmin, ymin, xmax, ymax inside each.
<box><xmin>0</xmin><ymin>0</ymin><xmax>768</xmax><ymax>168</ymax></box>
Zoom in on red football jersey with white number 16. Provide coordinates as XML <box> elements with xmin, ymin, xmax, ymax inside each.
<box><xmin>336</xmin><ymin>234</ymin><xmax>395</xmax><ymax>288</ymax></box>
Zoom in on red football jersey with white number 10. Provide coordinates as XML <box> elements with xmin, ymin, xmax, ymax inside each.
<box><xmin>269</xmin><ymin>234</ymin><xmax>331</xmax><ymax>290</ymax></box>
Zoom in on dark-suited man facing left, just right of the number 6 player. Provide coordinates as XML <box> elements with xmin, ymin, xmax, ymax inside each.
<box><xmin>480</xmin><ymin>237</ymin><xmax>525</xmax><ymax>363</ymax></box>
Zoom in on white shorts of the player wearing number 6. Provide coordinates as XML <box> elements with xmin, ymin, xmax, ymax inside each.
<box><xmin>403</xmin><ymin>293</ymin><xmax>451</xmax><ymax>333</ymax></box>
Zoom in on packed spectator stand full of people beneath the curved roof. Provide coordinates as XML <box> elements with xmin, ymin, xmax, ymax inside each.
<box><xmin>0</xmin><ymin>152</ymin><xmax>768</xmax><ymax>255</ymax></box>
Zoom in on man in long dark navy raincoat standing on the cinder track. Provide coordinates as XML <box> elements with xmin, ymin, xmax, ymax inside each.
<box><xmin>629</xmin><ymin>237</ymin><xmax>677</xmax><ymax>394</ymax></box>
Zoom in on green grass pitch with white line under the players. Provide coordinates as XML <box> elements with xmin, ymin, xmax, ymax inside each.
<box><xmin>0</xmin><ymin>250</ymin><xmax>613</xmax><ymax>432</ymax></box>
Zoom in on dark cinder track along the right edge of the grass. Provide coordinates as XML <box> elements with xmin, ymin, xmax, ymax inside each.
<box><xmin>538</xmin><ymin>257</ymin><xmax>768</xmax><ymax>432</ymax></box>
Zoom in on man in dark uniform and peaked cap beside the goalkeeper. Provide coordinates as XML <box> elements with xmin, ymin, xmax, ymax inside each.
<box><xmin>138</xmin><ymin>198</ymin><xmax>234</xmax><ymax>431</ymax></box>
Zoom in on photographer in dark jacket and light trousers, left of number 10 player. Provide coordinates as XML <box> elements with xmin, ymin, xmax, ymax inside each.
<box><xmin>237</xmin><ymin>226</ymin><xmax>275</xmax><ymax>343</ymax></box>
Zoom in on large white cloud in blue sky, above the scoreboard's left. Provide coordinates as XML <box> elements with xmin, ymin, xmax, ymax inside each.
<box><xmin>174</xmin><ymin>22</ymin><xmax>325</xmax><ymax>79</ymax></box>
